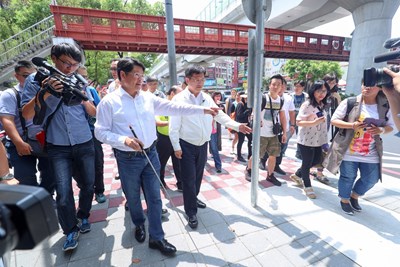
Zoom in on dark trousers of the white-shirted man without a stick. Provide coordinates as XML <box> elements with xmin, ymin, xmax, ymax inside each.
<box><xmin>180</xmin><ymin>139</ymin><xmax>208</xmax><ymax>216</ymax></box>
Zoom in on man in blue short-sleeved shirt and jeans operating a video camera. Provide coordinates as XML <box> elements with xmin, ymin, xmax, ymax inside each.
<box><xmin>22</xmin><ymin>43</ymin><xmax>96</xmax><ymax>251</ymax></box>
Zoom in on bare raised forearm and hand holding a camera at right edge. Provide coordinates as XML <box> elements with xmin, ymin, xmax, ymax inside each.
<box><xmin>382</xmin><ymin>68</ymin><xmax>400</xmax><ymax>131</ymax></box>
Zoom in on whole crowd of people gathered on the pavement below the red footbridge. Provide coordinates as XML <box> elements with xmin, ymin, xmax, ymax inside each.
<box><xmin>0</xmin><ymin>40</ymin><xmax>400</xmax><ymax>255</ymax></box>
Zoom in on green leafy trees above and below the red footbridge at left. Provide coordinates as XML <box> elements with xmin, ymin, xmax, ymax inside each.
<box><xmin>0</xmin><ymin>0</ymin><xmax>165</xmax><ymax>84</ymax></box>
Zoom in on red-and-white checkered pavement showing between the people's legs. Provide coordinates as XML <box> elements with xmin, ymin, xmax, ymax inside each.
<box><xmin>79</xmin><ymin>139</ymin><xmax>298</xmax><ymax>225</ymax></box>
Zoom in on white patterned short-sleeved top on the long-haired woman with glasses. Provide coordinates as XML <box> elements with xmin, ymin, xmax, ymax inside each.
<box><xmin>296</xmin><ymin>100</ymin><xmax>328</xmax><ymax>147</ymax></box>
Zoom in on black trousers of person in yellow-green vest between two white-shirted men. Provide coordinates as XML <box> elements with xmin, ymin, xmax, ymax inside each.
<box><xmin>157</xmin><ymin>133</ymin><xmax>181</xmax><ymax>184</ymax></box>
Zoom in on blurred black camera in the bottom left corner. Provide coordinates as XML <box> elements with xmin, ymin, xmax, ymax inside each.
<box><xmin>0</xmin><ymin>184</ymin><xmax>59</xmax><ymax>257</ymax></box>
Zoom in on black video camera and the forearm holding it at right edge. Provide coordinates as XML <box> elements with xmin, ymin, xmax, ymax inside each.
<box><xmin>364</xmin><ymin>38</ymin><xmax>400</xmax><ymax>131</ymax></box>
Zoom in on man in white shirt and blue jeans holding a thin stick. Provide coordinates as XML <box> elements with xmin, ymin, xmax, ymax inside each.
<box><xmin>95</xmin><ymin>58</ymin><xmax>216</xmax><ymax>255</ymax></box>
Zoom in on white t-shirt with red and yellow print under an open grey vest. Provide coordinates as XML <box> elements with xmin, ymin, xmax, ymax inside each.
<box><xmin>332</xmin><ymin>101</ymin><xmax>394</xmax><ymax>163</ymax></box>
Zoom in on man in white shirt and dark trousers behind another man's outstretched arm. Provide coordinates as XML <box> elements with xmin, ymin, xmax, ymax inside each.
<box><xmin>169</xmin><ymin>65</ymin><xmax>251</xmax><ymax>229</ymax></box>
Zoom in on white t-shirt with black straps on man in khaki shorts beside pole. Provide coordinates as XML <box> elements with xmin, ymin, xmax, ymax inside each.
<box><xmin>260</xmin><ymin>94</ymin><xmax>281</xmax><ymax>137</ymax></box>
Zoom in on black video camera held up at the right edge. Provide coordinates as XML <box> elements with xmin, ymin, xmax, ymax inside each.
<box><xmin>364</xmin><ymin>38</ymin><xmax>400</xmax><ymax>88</ymax></box>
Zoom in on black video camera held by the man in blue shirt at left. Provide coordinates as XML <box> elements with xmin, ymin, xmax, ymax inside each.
<box><xmin>32</xmin><ymin>57</ymin><xmax>88</xmax><ymax>106</ymax></box>
